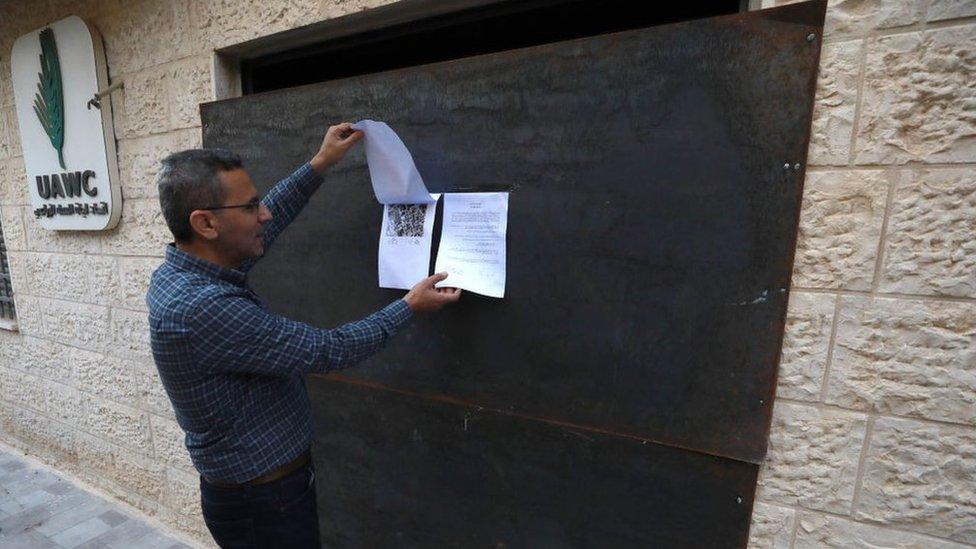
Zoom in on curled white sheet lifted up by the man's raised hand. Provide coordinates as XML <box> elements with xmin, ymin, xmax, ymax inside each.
<box><xmin>352</xmin><ymin>120</ymin><xmax>436</xmax><ymax>204</ymax></box>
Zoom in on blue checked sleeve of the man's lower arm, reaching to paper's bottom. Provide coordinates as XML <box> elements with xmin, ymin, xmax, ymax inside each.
<box><xmin>192</xmin><ymin>294</ymin><xmax>412</xmax><ymax>376</ymax></box>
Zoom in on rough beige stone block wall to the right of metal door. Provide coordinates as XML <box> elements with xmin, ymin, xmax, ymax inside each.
<box><xmin>750</xmin><ymin>0</ymin><xmax>976</xmax><ymax>548</ymax></box>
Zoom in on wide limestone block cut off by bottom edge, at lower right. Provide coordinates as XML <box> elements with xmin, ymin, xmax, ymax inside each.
<box><xmin>794</xmin><ymin>511</ymin><xmax>963</xmax><ymax>549</ymax></box>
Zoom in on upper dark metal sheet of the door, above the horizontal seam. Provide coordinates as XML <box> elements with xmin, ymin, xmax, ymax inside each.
<box><xmin>202</xmin><ymin>2</ymin><xmax>825</xmax><ymax>463</ymax></box>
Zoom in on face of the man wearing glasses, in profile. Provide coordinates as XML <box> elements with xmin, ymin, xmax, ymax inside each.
<box><xmin>214</xmin><ymin>169</ymin><xmax>271</xmax><ymax>265</ymax></box>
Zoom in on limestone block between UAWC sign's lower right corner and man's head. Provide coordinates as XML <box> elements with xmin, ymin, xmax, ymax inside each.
<box><xmin>102</xmin><ymin>199</ymin><xmax>173</xmax><ymax>257</ymax></box>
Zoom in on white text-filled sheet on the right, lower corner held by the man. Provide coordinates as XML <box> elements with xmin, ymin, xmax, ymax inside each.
<box><xmin>434</xmin><ymin>193</ymin><xmax>508</xmax><ymax>297</ymax></box>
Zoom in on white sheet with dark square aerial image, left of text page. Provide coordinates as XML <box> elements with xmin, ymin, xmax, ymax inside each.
<box><xmin>379</xmin><ymin>194</ymin><xmax>440</xmax><ymax>290</ymax></box>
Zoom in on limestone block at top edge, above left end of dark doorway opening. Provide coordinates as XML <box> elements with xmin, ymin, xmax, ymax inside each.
<box><xmin>190</xmin><ymin>0</ymin><xmax>319</xmax><ymax>48</ymax></box>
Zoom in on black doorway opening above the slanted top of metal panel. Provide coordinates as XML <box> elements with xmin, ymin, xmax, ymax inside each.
<box><xmin>242</xmin><ymin>0</ymin><xmax>747</xmax><ymax>95</ymax></box>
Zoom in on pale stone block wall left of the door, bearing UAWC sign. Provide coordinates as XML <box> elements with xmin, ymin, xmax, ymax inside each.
<box><xmin>0</xmin><ymin>0</ymin><xmax>396</xmax><ymax>545</ymax></box>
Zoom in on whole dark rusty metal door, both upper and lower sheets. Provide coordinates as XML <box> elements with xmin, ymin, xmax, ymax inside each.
<box><xmin>202</xmin><ymin>1</ymin><xmax>825</xmax><ymax>547</ymax></box>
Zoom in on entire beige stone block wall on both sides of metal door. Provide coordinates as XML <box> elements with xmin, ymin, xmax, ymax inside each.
<box><xmin>0</xmin><ymin>0</ymin><xmax>976</xmax><ymax>547</ymax></box>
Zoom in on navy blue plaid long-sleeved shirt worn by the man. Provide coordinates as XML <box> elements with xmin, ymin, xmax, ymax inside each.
<box><xmin>146</xmin><ymin>164</ymin><xmax>411</xmax><ymax>483</ymax></box>
